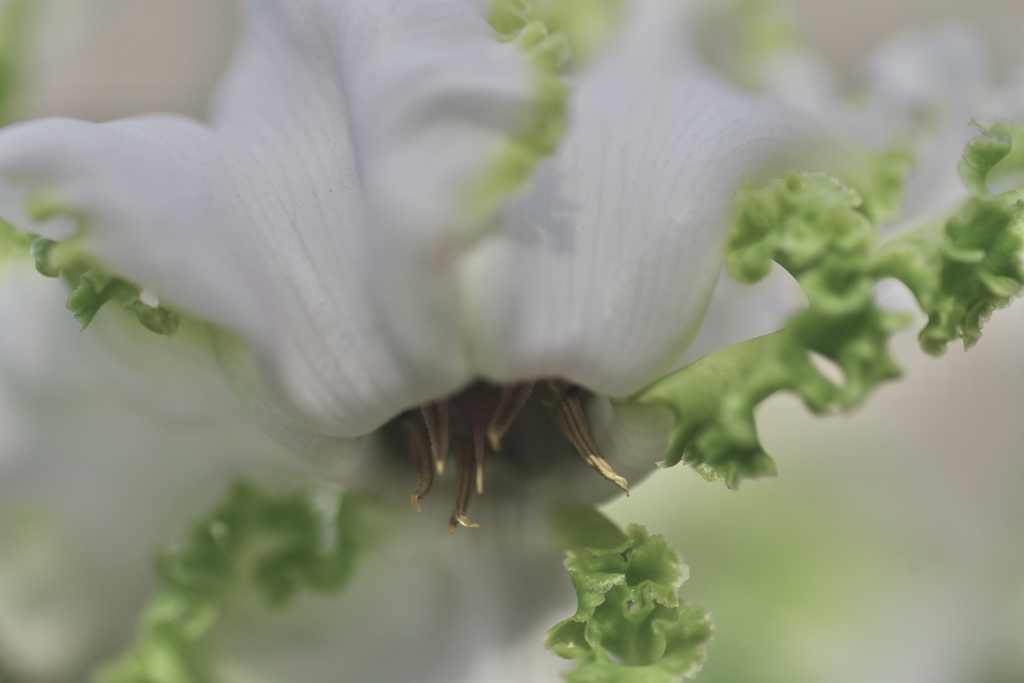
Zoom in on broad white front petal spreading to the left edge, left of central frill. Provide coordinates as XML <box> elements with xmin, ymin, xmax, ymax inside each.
<box><xmin>0</xmin><ymin>0</ymin><xmax>552</xmax><ymax>436</ymax></box>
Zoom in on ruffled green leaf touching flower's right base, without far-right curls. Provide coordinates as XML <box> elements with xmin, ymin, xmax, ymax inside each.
<box><xmin>634</xmin><ymin>174</ymin><xmax>908</xmax><ymax>486</ymax></box>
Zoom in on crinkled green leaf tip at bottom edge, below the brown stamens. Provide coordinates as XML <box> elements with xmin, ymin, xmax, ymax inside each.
<box><xmin>547</xmin><ymin>520</ymin><xmax>712</xmax><ymax>683</ymax></box>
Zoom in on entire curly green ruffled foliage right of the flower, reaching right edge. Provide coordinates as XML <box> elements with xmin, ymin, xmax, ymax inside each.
<box><xmin>631</xmin><ymin>126</ymin><xmax>1024</xmax><ymax>486</ymax></box>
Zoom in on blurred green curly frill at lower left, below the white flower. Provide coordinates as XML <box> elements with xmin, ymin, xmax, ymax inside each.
<box><xmin>94</xmin><ymin>482</ymin><xmax>382</xmax><ymax>683</ymax></box>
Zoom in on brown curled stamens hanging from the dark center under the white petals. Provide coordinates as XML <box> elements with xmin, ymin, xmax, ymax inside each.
<box><xmin>396</xmin><ymin>380</ymin><xmax>629</xmax><ymax>533</ymax></box>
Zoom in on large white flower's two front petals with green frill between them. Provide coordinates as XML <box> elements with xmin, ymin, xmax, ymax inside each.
<box><xmin>0</xmin><ymin>0</ymin><xmax>839</xmax><ymax>518</ymax></box>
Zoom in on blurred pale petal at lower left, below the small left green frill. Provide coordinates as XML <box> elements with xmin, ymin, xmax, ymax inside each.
<box><xmin>0</xmin><ymin>264</ymin><xmax>296</xmax><ymax>681</ymax></box>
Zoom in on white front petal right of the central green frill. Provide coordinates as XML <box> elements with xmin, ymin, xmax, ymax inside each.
<box><xmin>464</xmin><ymin>0</ymin><xmax>823</xmax><ymax>396</ymax></box>
